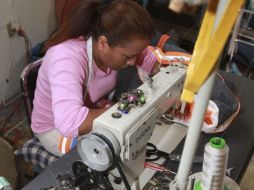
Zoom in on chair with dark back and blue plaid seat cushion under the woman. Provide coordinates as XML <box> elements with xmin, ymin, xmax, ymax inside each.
<box><xmin>14</xmin><ymin>58</ymin><xmax>58</xmax><ymax>168</ymax></box>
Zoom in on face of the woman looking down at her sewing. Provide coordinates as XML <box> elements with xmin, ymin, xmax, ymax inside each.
<box><xmin>96</xmin><ymin>36</ymin><xmax>149</xmax><ymax>70</ymax></box>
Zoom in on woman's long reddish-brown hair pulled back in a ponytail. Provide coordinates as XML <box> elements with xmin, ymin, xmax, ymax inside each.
<box><xmin>44</xmin><ymin>0</ymin><xmax>155</xmax><ymax>51</ymax></box>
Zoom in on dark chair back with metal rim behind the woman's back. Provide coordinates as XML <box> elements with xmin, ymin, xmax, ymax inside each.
<box><xmin>20</xmin><ymin>58</ymin><xmax>43</xmax><ymax>125</ymax></box>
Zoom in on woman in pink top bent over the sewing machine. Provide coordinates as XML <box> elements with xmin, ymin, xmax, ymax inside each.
<box><xmin>32</xmin><ymin>0</ymin><xmax>158</xmax><ymax>156</ymax></box>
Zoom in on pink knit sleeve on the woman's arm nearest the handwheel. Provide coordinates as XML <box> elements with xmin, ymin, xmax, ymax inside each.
<box><xmin>48</xmin><ymin>49</ymin><xmax>89</xmax><ymax>136</ymax></box>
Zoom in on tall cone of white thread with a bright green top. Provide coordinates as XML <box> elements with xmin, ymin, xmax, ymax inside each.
<box><xmin>200</xmin><ymin>137</ymin><xmax>229</xmax><ymax>190</ymax></box>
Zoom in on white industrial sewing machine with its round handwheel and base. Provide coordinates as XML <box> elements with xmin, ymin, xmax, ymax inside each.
<box><xmin>78</xmin><ymin>63</ymin><xmax>186</xmax><ymax>189</ymax></box>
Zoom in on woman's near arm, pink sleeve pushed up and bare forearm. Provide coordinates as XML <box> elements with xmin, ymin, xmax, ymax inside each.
<box><xmin>46</xmin><ymin>39</ymin><xmax>116</xmax><ymax>136</ymax></box>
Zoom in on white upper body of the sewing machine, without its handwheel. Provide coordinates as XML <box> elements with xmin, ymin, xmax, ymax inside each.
<box><xmin>93</xmin><ymin>65</ymin><xmax>185</xmax><ymax>161</ymax></box>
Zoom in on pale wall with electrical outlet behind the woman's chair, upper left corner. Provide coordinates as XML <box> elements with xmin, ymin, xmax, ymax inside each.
<box><xmin>0</xmin><ymin>0</ymin><xmax>56</xmax><ymax>105</ymax></box>
